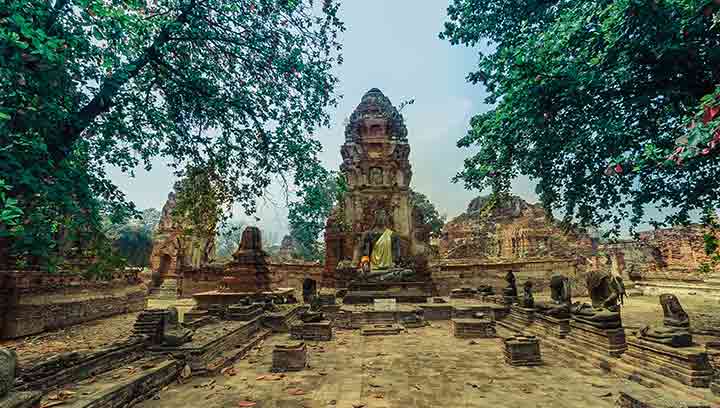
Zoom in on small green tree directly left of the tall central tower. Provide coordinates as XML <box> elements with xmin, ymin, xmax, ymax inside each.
<box><xmin>288</xmin><ymin>167</ymin><xmax>347</xmax><ymax>260</ymax></box>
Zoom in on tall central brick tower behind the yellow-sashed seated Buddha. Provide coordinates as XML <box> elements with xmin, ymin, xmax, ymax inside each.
<box><xmin>325</xmin><ymin>88</ymin><xmax>427</xmax><ymax>287</ymax></box>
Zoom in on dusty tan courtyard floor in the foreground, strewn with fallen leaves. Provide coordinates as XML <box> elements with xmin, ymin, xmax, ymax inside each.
<box><xmin>135</xmin><ymin>322</ymin><xmax>624</xmax><ymax>408</ymax></box>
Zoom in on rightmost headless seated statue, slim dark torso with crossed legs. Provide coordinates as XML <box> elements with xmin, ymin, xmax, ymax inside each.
<box><xmin>637</xmin><ymin>294</ymin><xmax>692</xmax><ymax>347</ymax></box>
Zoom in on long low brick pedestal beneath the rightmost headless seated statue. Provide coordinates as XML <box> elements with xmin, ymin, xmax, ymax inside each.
<box><xmin>622</xmin><ymin>336</ymin><xmax>713</xmax><ymax>388</ymax></box>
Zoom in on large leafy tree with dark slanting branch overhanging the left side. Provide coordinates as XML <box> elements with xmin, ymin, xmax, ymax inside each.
<box><xmin>0</xmin><ymin>0</ymin><xmax>344</xmax><ymax>267</ymax></box>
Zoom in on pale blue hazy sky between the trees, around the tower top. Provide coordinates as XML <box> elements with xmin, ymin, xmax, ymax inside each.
<box><xmin>111</xmin><ymin>0</ymin><xmax>536</xmax><ymax>241</ymax></box>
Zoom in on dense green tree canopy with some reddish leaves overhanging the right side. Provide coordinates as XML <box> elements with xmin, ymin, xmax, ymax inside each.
<box><xmin>441</xmin><ymin>0</ymin><xmax>720</xmax><ymax>231</ymax></box>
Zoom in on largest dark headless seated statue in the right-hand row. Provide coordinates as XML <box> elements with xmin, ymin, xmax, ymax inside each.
<box><xmin>571</xmin><ymin>271</ymin><xmax>625</xmax><ymax>329</ymax></box>
